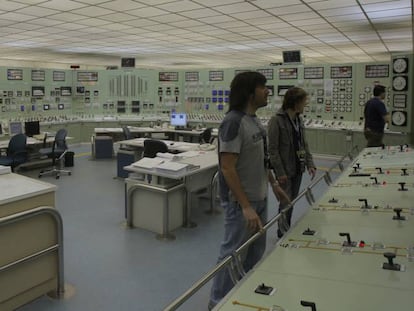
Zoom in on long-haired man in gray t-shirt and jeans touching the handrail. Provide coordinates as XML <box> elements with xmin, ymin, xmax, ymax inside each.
<box><xmin>208</xmin><ymin>71</ymin><xmax>288</xmax><ymax>310</ymax></box>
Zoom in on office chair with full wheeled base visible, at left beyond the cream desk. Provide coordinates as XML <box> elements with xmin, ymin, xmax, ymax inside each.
<box><xmin>39</xmin><ymin>129</ymin><xmax>72</xmax><ymax>179</ymax></box>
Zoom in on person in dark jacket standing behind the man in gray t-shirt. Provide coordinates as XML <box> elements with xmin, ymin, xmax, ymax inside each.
<box><xmin>268</xmin><ymin>87</ymin><xmax>316</xmax><ymax>238</ymax></box>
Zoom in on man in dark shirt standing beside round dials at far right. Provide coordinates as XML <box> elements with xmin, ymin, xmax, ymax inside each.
<box><xmin>364</xmin><ymin>85</ymin><xmax>390</xmax><ymax>147</ymax></box>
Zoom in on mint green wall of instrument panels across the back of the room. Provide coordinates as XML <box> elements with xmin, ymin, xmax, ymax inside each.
<box><xmin>0</xmin><ymin>54</ymin><xmax>414</xmax><ymax>138</ymax></box>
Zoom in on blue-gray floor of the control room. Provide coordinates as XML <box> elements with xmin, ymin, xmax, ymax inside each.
<box><xmin>18</xmin><ymin>145</ymin><xmax>346</xmax><ymax>311</ymax></box>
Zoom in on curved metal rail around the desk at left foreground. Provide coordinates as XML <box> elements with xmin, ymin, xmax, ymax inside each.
<box><xmin>0</xmin><ymin>206</ymin><xmax>65</xmax><ymax>298</ymax></box>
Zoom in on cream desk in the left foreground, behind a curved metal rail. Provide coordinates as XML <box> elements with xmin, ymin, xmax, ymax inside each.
<box><xmin>0</xmin><ymin>173</ymin><xmax>59</xmax><ymax>311</ymax></box>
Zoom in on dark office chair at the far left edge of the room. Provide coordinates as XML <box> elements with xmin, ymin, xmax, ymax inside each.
<box><xmin>0</xmin><ymin>134</ymin><xmax>28</xmax><ymax>172</ymax></box>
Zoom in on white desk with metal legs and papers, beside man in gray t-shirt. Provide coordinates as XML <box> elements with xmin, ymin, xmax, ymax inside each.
<box><xmin>125</xmin><ymin>151</ymin><xmax>218</xmax><ymax>237</ymax></box>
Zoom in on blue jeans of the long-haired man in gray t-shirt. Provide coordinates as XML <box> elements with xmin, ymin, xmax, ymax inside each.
<box><xmin>209</xmin><ymin>199</ymin><xmax>267</xmax><ymax>307</ymax></box>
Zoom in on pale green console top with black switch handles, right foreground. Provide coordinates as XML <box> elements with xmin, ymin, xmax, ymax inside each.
<box><xmin>214</xmin><ymin>148</ymin><xmax>414</xmax><ymax>311</ymax></box>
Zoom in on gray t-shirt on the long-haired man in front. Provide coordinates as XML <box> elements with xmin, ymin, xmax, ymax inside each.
<box><xmin>219</xmin><ymin>111</ymin><xmax>267</xmax><ymax>201</ymax></box>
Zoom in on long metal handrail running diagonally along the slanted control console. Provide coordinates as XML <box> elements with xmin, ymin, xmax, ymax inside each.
<box><xmin>163</xmin><ymin>153</ymin><xmax>349</xmax><ymax>311</ymax></box>
